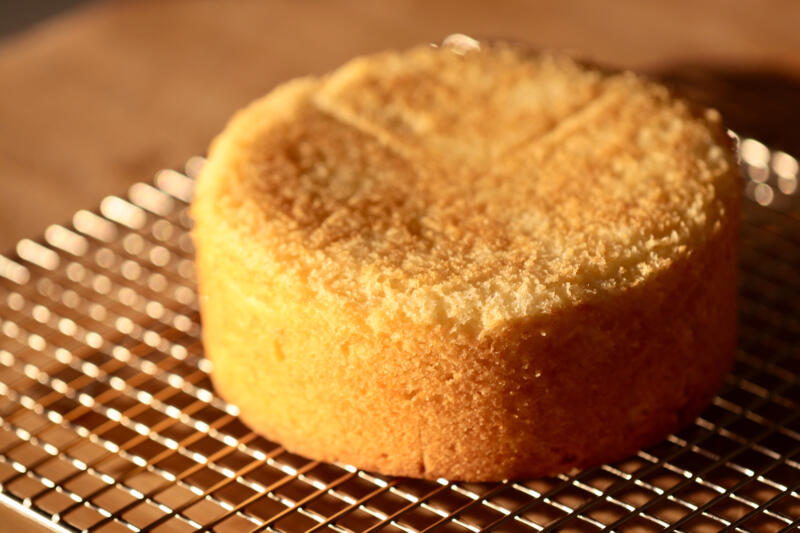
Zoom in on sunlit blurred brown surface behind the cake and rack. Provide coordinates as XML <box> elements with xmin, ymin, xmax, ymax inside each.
<box><xmin>0</xmin><ymin>0</ymin><xmax>800</xmax><ymax>250</ymax></box>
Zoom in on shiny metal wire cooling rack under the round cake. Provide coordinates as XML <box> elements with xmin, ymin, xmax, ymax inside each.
<box><xmin>0</xmin><ymin>139</ymin><xmax>800</xmax><ymax>532</ymax></box>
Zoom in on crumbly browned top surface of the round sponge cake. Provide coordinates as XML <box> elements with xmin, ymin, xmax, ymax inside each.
<box><xmin>197</xmin><ymin>40</ymin><xmax>739</xmax><ymax>334</ymax></box>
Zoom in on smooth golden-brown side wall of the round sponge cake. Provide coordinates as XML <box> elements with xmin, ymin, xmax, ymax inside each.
<box><xmin>195</xmin><ymin>189</ymin><xmax>737</xmax><ymax>480</ymax></box>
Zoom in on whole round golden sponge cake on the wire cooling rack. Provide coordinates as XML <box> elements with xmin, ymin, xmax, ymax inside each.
<box><xmin>192</xmin><ymin>44</ymin><xmax>741</xmax><ymax>481</ymax></box>
